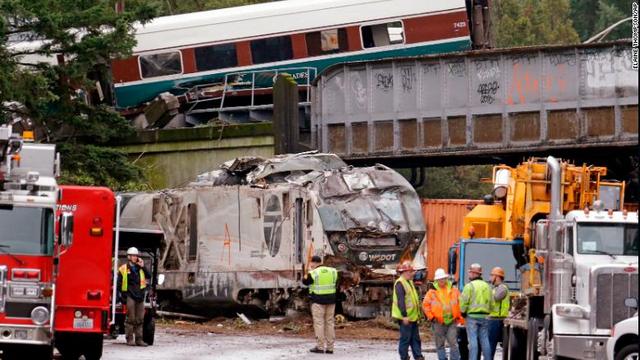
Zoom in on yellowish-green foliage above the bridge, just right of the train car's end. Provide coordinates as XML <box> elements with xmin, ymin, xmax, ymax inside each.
<box><xmin>493</xmin><ymin>0</ymin><xmax>579</xmax><ymax>47</ymax></box>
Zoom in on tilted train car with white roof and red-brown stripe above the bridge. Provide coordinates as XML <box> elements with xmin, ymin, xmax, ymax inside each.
<box><xmin>112</xmin><ymin>0</ymin><xmax>471</xmax><ymax>110</ymax></box>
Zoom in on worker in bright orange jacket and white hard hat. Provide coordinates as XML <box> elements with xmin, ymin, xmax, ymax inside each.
<box><xmin>422</xmin><ymin>269</ymin><xmax>464</xmax><ymax>360</ymax></box>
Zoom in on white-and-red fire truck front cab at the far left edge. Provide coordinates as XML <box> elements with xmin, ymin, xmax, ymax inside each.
<box><xmin>0</xmin><ymin>125</ymin><xmax>72</xmax><ymax>359</ymax></box>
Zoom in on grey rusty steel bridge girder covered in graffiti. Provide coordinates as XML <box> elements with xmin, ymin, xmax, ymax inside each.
<box><xmin>312</xmin><ymin>41</ymin><xmax>638</xmax><ymax>159</ymax></box>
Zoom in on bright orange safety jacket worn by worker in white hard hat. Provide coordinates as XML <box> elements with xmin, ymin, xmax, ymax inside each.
<box><xmin>422</xmin><ymin>282</ymin><xmax>464</xmax><ymax>325</ymax></box>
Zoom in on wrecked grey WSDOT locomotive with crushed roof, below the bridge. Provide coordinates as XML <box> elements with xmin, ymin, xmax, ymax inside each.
<box><xmin>121</xmin><ymin>153</ymin><xmax>425</xmax><ymax>318</ymax></box>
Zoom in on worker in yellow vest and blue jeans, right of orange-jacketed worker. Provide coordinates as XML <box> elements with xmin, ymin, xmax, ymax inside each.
<box><xmin>460</xmin><ymin>263</ymin><xmax>492</xmax><ymax>360</ymax></box>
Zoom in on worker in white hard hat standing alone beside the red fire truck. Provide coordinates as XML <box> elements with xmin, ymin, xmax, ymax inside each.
<box><xmin>117</xmin><ymin>247</ymin><xmax>150</xmax><ymax>346</ymax></box>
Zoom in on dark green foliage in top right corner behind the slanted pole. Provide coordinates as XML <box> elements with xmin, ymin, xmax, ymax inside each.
<box><xmin>571</xmin><ymin>0</ymin><xmax>632</xmax><ymax>41</ymax></box>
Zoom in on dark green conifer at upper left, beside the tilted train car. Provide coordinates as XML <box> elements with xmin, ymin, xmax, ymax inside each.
<box><xmin>0</xmin><ymin>0</ymin><xmax>156</xmax><ymax>188</ymax></box>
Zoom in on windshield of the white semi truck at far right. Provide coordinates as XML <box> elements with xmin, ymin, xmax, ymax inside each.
<box><xmin>577</xmin><ymin>223</ymin><xmax>639</xmax><ymax>256</ymax></box>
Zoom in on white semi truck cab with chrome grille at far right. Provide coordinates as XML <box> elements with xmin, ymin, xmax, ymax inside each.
<box><xmin>551</xmin><ymin>206</ymin><xmax>640</xmax><ymax>358</ymax></box>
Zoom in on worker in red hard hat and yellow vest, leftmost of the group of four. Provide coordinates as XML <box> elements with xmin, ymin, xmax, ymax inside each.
<box><xmin>391</xmin><ymin>261</ymin><xmax>424</xmax><ymax>360</ymax></box>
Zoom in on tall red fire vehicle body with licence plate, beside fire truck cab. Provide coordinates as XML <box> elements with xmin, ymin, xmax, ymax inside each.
<box><xmin>53</xmin><ymin>186</ymin><xmax>115</xmax><ymax>360</ymax></box>
